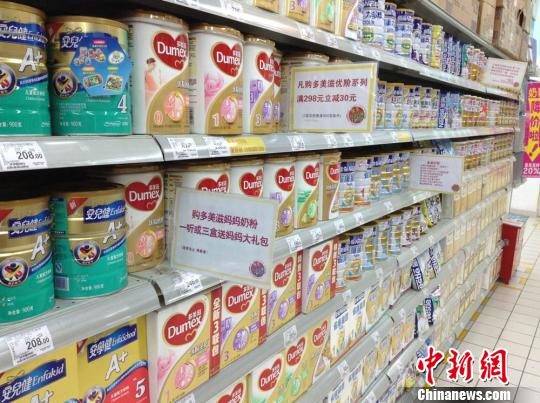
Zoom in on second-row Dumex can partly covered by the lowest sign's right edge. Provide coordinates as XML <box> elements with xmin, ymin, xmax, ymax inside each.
<box><xmin>263</xmin><ymin>156</ymin><xmax>296</xmax><ymax>237</ymax></box>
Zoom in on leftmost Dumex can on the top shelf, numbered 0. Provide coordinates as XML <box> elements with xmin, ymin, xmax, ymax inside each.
<box><xmin>123</xmin><ymin>10</ymin><xmax>190</xmax><ymax>134</ymax></box>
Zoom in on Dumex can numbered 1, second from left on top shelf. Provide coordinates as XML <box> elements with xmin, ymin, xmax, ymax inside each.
<box><xmin>189</xmin><ymin>24</ymin><xmax>244</xmax><ymax>135</ymax></box>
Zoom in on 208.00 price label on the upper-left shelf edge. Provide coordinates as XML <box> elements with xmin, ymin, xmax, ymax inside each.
<box><xmin>0</xmin><ymin>141</ymin><xmax>47</xmax><ymax>172</ymax></box>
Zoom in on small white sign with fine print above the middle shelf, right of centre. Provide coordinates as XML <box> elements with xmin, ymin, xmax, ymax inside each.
<box><xmin>410</xmin><ymin>154</ymin><xmax>464</xmax><ymax>193</ymax></box>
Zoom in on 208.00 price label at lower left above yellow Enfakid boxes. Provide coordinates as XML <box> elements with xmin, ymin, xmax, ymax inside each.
<box><xmin>6</xmin><ymin>325</ymin><xmax>54</xmax><ymax>366</ymax></box>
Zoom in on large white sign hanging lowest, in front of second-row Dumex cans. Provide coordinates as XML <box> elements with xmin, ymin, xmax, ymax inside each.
<box><xmin>172</xmin><ymin>188</ymin><xmax>277</xmax><ymax>288</ymax></box>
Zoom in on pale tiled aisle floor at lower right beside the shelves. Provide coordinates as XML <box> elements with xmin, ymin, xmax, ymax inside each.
<box><xmin>437</xmin><ymin>218</ymin><xmax>540</xmax><ymax>403</ymax></box>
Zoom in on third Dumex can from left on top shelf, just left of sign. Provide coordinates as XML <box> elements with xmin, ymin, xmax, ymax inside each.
<box><xmin>243</xmin><ymin>36</ymin><xmax>275</xmax><ymax>134</ymax></box>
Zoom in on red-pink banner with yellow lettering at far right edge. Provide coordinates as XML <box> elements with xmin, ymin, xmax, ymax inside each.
<box><xmin>523</xmin><ymin>83</ymin><xmax>540</xmax><ymax>178</ymax></box>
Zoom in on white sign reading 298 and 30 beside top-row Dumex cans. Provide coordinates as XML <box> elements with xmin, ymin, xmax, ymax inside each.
<box><xmin>291</xmin><ymin>63</ymin><xmax>378</xmax><ymax>132</ymax></box>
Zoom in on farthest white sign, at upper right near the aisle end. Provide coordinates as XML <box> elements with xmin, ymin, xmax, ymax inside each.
<box><xmin>481</xmin><ymin>57</ymin><xmax>527</xmax><ymax>92</ymax></box>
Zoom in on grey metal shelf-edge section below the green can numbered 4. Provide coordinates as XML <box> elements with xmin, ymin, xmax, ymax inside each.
<box><xmin>0</xmin><ymin>135</ymin><xmax>163</xmax><ymax>172</ymax></box>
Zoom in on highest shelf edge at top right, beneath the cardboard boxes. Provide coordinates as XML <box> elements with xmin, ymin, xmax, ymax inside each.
<box><xmin>402</xmin><ymin>0</ymin><xmax>509</xmax><ymax>59</ymax></box>
